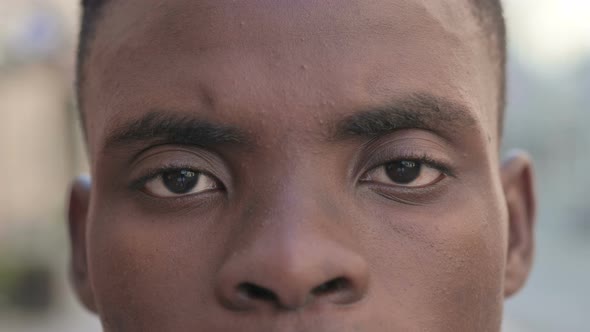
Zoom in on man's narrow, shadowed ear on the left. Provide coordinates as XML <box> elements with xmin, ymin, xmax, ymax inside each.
<box><xmin>68</xmin><ymin>176</ymin><xmax>96</xmax><ymax>312</ymax></box>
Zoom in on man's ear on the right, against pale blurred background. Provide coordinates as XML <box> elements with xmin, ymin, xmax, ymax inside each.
<box><xmin>501</xmin><ymin>151</ymin><xmax>536</xmax><ymax>297</ymax></box>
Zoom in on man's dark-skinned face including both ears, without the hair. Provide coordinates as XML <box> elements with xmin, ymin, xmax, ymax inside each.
<box><xmin>69</xmin><ymin>0</ymin><xmax>535</xmax><ymax>332</ymax></box>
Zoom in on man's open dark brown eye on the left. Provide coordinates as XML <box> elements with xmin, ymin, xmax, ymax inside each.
<box><xmin>143</xmin><ymin>169</ymin><xmax>220</xmax><ymax>197</ymax></box>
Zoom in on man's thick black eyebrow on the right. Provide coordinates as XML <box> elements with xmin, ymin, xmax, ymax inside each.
<box><xmin>331</xmin><ymin>93</ymin><xmax>477</xmax><ymax>140</ymax></box>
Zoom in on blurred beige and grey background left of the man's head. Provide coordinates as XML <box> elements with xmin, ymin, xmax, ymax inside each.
<box><xmin>0</xmin><ymin>0</ymin><xmax>98</xmax><ymax>332</ymax></box>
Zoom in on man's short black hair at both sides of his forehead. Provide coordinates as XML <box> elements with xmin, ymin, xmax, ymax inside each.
<box><xmin>76</xmin><ymin>0</ymin><xmax>506</xmax><ymax>127</ymax></box>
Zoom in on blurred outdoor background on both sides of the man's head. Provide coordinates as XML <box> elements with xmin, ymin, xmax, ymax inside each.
<box><xmin>0</xmin><ymin>0</ymin><xmax>590</xmax><ymax>332</ymax></box>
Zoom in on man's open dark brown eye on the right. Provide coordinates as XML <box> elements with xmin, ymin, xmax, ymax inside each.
<box><xmin>362</xmin><ymin>160</ymin><xmax>445</xmax><ymax>188</ymax></box>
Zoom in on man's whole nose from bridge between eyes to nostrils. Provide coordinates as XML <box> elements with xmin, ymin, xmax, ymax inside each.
<box><xmin>217</xmin><ymin>165</ymin><xmax>368</xmax><ymax>309</ymax></box>
